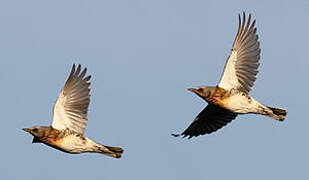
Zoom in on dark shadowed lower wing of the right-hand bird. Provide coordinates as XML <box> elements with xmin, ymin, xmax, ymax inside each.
<box><xmin>172</xmin><ymin>103</ymin><xmax>237</xmax><ymax>139</ymax></box>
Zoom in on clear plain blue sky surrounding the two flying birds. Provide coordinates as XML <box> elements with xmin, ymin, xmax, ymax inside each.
<box><xmin>0</xmin><ymin>0</ymin><xmax>309</xmax><ymax>180</ymax></box>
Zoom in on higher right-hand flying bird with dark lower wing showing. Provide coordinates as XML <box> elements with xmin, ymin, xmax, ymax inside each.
<box><xmin>172</xmin><ymin>13</ymin><xmax>287</xmax><ymax>139</ymax></box>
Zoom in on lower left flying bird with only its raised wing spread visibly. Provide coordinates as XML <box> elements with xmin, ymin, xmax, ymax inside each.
<box><xmin>23</xmin><ymin>64</ymin><xmax>123</xmax><ymax>158</ymax></box>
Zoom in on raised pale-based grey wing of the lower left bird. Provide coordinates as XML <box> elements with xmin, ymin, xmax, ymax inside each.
<box><xmin>52</xmin><ymin>64</ymin><xmax>91</xmax><ymax>134</ymax></box>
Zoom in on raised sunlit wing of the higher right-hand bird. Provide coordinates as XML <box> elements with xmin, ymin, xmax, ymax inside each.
<box><xmin>219</xmin><ymin>13</ymin><xmax>261</xmax><ymax>93</ymax></box>
